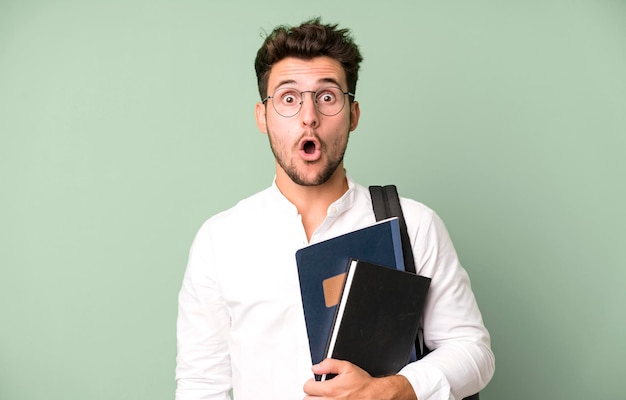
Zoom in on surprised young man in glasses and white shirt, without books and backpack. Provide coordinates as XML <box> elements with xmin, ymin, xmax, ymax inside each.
<box><xmin>176</xmin><ymin>20</ymin><xmax>494</xmax><ymax>400</ymax></box>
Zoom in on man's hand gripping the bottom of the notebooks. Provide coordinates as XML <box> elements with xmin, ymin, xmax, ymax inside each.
<box><xmin>304</xmin><ymin>359</ymin><xmax>417</xmax><ymax>400</ymax></box>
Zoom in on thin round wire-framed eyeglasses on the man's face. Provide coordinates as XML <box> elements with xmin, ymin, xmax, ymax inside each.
<box><xmin>263</xmin><ymin>86</ymin><xmax>354</xmax><ymax>118</ymax></box>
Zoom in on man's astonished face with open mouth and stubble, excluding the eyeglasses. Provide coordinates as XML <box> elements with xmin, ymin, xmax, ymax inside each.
<box><xmin>256</xmin><ymin>57</ymin><xmax>359</xmax><ymax>186</ymax></box>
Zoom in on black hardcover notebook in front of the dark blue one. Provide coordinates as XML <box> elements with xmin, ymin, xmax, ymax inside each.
<box><xmin>321</xmin><ymin>260</ymin><xmax>430</xmax><ymax>380</ymax></box>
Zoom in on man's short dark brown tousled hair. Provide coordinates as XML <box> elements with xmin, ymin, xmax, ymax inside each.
<box><xmin>254</xmin><ymin>17</ymin><xmax>363</xmax><ymax>99</ymax></box>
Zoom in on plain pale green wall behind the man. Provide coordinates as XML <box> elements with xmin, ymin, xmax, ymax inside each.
<box><xmin>0</xmin><ymin>0</ymin><xmax>626</xmax><ymax>400</ymax></box>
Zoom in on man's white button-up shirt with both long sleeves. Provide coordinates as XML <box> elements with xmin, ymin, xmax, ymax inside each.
<box><xmin>176</xmin><ymin>179</ymin><xmax>494</xmax><ymax>400</ymax></box>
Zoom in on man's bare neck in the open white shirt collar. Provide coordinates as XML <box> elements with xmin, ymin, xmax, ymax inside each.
<box><xmin>276</xmin><ymin>166</ymin><xmax>348</xmax><ymax>240</ymax></box>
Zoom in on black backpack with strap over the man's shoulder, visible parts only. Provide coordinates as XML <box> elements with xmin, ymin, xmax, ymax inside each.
<box><xmin>369</xmin><ymin>185</ymin><xmax>480</xmax><ymax>400</ymax></box>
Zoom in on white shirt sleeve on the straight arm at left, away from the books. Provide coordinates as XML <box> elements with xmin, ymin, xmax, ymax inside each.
<box><xmin>176</xmin><ymin>223</ymin><xmax>232</xmax><ymax>400</ymax></box>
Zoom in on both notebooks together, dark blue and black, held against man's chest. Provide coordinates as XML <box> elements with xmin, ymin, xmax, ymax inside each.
<box><xmin>296</xmin><ymin>217</ymin><xmax>430</xmax><ymax>380</ymax></box>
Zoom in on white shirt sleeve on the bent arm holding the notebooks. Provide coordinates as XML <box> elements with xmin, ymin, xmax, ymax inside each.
<box><xmin>400</xmin><ymin>200</ymin><xmax>495</xmax><ymax>400</ymax></box>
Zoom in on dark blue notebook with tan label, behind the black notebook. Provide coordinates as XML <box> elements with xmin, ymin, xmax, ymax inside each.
<box><xmin>296</xmin><ymin>217</ymin><xmax>404</xmax><ymax>370</ymax></box>
